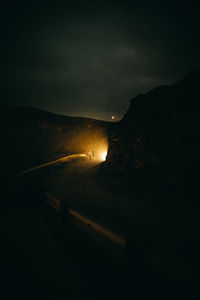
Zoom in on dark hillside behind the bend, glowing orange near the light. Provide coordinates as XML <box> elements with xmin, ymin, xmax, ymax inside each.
<box><xmin>0</xmin><ymin>106</ymin><xmax>109</xmax><ymax>177</ymax></box>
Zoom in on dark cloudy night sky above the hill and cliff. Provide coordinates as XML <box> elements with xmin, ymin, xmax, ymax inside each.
<box><xmin>0</xmin><ymin>0</ymin><xmax>200</xmax><ymax>120</ymax></box>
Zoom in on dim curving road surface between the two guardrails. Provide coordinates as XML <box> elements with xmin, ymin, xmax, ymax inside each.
<box><xmin>43</xmin><ymin>159</ymin><xmax>156</xmax><ymax>236</ymax></box>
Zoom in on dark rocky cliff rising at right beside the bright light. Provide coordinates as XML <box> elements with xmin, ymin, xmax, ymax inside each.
<box><xmin>106</xmin><ymin>70</ymin><xmax>200</xmax><ymax>193</ymax></box>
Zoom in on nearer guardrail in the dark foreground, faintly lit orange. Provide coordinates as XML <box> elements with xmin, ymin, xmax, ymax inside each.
<box><xmin>45</xmin><ymin>193</ymin><xmax>165</xmax><ymax>281</ymax></box>
